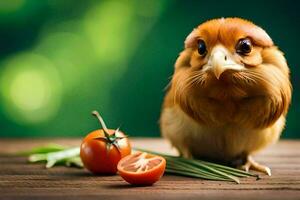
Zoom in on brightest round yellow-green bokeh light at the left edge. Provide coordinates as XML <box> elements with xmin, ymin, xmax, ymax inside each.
<box><xmin>0</xmin><ymin>53</ymin><xmax>61</xmax><ymax>124</ymax></box>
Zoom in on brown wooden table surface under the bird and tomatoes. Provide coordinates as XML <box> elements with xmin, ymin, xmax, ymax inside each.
<box><xmin>0</xmin><ymin>138</ymin><xmax>300</xmax><ymax>200</ymax></box>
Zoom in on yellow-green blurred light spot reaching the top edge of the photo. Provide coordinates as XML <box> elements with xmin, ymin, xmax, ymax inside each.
<box><xmin>83</xmin><ymin>0</ymin><xmax>133</xmax><ymax>62</ymax></box>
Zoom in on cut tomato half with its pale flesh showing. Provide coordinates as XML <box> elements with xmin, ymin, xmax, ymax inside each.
<box><xmin>118</xmin><ymin>152</ymin><xmax>166</xmax><ymax>185</ymax></box>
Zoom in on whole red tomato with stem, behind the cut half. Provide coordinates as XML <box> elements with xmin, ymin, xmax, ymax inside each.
<box><xmin>80</xmin><ymin>111</ymin><xmax>131</xmax><ymax>174</ymax></box>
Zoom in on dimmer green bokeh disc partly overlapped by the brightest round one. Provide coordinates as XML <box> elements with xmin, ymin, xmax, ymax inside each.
<box><xmin>33</xmin><ymin>30</ymin><xmax>96</xmax><ymax>92</ymax></box>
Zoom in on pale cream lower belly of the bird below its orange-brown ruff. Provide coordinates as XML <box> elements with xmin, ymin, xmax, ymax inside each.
<box><xmin>162</xmin><ymin>97</ymin><xmax>285</xmax><ymax>164</ymax></box>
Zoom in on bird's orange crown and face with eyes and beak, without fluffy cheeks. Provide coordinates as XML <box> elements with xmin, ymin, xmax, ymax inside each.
<box><xmin>185</xmin><ymin>18</ymin><xmax>273</xmax><ymax>80</ymax></box>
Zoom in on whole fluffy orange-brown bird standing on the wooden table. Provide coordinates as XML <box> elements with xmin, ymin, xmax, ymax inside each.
<box><xmin>159</xmin><ymin>17</ymin><xmax>292</xmax><ymax>176</ymax></box>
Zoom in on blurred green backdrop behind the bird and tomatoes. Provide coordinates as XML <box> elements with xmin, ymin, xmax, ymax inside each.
<box><xmin>0</xmin><ymin>0</ymin><xmax>300</xmax><ymax>138</ymax></box>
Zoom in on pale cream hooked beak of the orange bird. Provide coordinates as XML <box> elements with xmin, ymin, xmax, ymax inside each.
<box><xmin>208</xmin><ymin>46</ymin><xmax>244</xmax><ymax>79</ymax></box>
